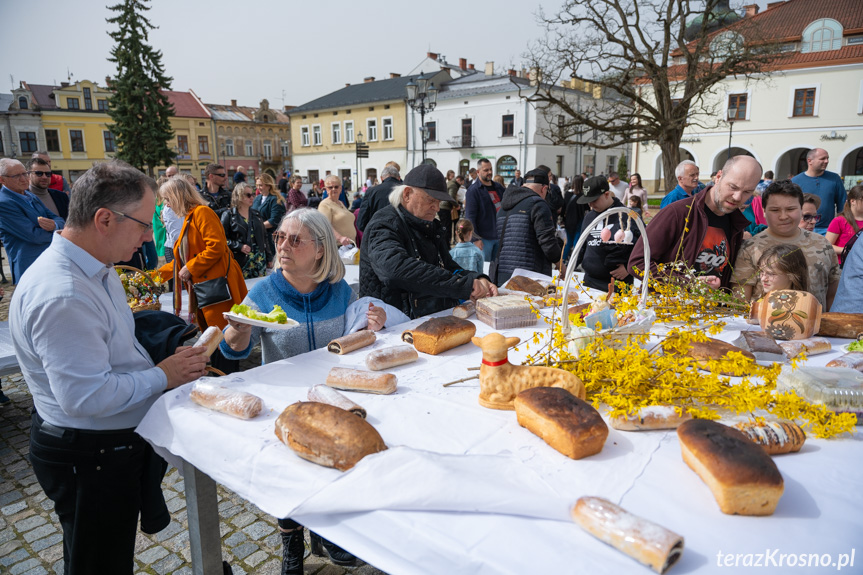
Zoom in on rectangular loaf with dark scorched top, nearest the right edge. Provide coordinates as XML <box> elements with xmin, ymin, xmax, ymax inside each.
<box><xmin>677</xmin><ymin>419</ymin><xmax>784</xmax><ymax>515</ymax></box>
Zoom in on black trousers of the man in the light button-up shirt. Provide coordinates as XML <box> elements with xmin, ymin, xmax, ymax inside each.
<box><xmin>30</xmin><ymin>411</ymin><xmax>171</xmax><ymax>575</ymax></box>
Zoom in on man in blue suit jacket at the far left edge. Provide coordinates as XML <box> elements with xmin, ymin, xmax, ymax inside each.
<box><xmin>0</xmin><ymin>158</ymin><xmax>65</xmax><ymax>283</ymax></box>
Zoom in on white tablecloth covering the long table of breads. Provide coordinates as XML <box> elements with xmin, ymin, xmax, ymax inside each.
<box><xmin>138</xmin><ymin>296</ymin><xmax>863</xmax><ymax>574</ymax></box>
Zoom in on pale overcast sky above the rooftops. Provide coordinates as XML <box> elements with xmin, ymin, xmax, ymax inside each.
<box><xmin>0</xmin><ymin>0</ymin><xmax>767</xmax><ymax>107</ymax></box>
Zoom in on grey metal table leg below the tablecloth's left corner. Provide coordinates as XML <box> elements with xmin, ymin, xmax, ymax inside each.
<box><xmin>183</xmin><ymin>461</ymin><xmax>222</xmax><ymax>575</ymax></box>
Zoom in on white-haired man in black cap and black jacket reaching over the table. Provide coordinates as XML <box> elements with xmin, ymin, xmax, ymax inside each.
<box><xmin>360</xmin><ymin>164</ymin><xmax>497</xmax><ymax>318</ymax></box>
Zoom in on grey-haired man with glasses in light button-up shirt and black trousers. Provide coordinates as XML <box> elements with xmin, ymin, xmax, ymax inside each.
<box><xmin>9</xmin><ymin>162</ymin><xmax>207</xmax><ymax>575</ymax></box>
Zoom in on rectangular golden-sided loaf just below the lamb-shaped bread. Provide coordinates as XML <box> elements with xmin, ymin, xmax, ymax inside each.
<box><xmin>514</xmin><ymin>387</ymin><xmax>608</xmax><ymax>459</ymax></box>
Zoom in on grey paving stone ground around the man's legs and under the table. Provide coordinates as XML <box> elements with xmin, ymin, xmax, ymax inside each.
<box><xmin>0</xmin><ymin>284</ymin><xmax>385</xmax><ymax>575</ymax></box>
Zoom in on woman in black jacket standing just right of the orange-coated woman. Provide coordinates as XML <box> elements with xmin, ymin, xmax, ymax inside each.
<box><xmin>221</xmin><ymin>182</ymin><xmax>273</xmax><ymax>279</ymax></box>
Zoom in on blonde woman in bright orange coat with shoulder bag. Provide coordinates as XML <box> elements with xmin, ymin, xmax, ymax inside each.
<box><xmin>159</xmin><ymin>177</ymin><xmax>248</xmax><ymax>373</ymax></box>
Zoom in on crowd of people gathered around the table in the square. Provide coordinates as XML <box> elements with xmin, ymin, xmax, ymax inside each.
<box><xmin>0</xmin><ymin>142</ymin><xmax>863</xmax><ymax>573</ymax></box>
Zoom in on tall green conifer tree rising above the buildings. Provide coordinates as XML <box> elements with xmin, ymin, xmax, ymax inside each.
<box><xmin>107</xmin><ymin>0</ymin><xmax>174</xmax><ymax>175</ymax></box>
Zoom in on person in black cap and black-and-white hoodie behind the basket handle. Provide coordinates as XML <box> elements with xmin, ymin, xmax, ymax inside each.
<box><xmin>576</xmin><ymin>176</ymin><xmax>641</xmax><ymax>291</ymax></box>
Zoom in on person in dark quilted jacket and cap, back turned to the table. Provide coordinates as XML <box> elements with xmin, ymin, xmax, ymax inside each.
<box><xmin>490</xmin><ymin>168</ymin><xmax>562</xmax><ymax>285</ymax></box>
